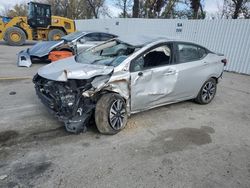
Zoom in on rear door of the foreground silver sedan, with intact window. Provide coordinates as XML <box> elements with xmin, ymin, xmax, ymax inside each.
<box><xmin>169</xmin><ymin>42</ymin><xmax>215</xmax><ymax>98</ymax></box>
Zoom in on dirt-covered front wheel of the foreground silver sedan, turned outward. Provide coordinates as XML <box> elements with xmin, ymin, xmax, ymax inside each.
<box><xmin>95</xmin><ymin>93</ymin><xmax>128</xmax><ymax>135</ymax></box>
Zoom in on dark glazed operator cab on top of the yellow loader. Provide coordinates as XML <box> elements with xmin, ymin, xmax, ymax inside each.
<box><xmin>28</xmin><ymin>2</ymin><xmax>51</xmax><ymax>28</ymax></box>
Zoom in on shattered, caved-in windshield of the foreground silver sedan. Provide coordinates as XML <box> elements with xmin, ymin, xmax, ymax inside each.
<box><xmin>76</xmin><ymin>40</ymin><xmax>135</xmax><ymax>67</ymax></box>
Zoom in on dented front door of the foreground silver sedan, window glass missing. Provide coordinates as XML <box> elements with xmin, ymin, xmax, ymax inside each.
<box><xmin>130</xmin><ymin>43</ymin><xmax>178</xmax><ymax>112</ymax></box>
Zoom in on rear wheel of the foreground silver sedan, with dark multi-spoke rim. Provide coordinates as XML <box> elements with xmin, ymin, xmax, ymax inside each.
<box><xmin>195</xmin><ymin>78</ymin><xmax>217</xmax><ymax>104</ymax></box>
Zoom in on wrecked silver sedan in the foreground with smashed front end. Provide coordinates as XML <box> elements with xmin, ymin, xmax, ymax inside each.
<box><xmin>33</xmin><ymin>36</ymin><xmax>227</xmax><ymax>134</ymax></box>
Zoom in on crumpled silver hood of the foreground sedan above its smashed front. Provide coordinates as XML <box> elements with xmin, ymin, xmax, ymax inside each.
<box><xmin>38</xmin><ymin>56</ymin><xmax>114</xmax><ymax>81</ymax></box>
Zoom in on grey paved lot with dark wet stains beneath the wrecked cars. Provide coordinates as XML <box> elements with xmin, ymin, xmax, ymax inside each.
<box><xmin>0</xmin><ymin>42</ymin><xmax>250</xmax><ymax>188</ymax></box>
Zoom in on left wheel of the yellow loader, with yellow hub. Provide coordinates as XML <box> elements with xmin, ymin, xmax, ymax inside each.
<box><xmin>4</xmin><ymin>27</ymin><xmax>26</xmax><ymax>46</ymax></box>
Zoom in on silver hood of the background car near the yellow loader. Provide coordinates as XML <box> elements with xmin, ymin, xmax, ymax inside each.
<box><xmin>28</xmin><ymin>40</ymin><xmax>64</xmax><ymax>57</ymax></box>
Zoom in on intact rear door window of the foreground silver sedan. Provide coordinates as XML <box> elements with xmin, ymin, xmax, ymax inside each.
<box><xmin>177</xmin><ymin>44</ymin><xmax>207</xmax><ymax>63</ymax></box>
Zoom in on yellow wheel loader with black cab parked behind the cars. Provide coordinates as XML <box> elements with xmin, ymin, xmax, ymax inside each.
<box><xmin>0</xmin><ymin>2</ymin><xmax>75</xmax><ymax>46</ymax></box>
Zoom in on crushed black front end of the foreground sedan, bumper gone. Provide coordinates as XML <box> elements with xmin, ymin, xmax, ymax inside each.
<box><xmin>33</xmin><ymin>74</ymin><xmax>95</xmax><ymax>133</ymax></box>
